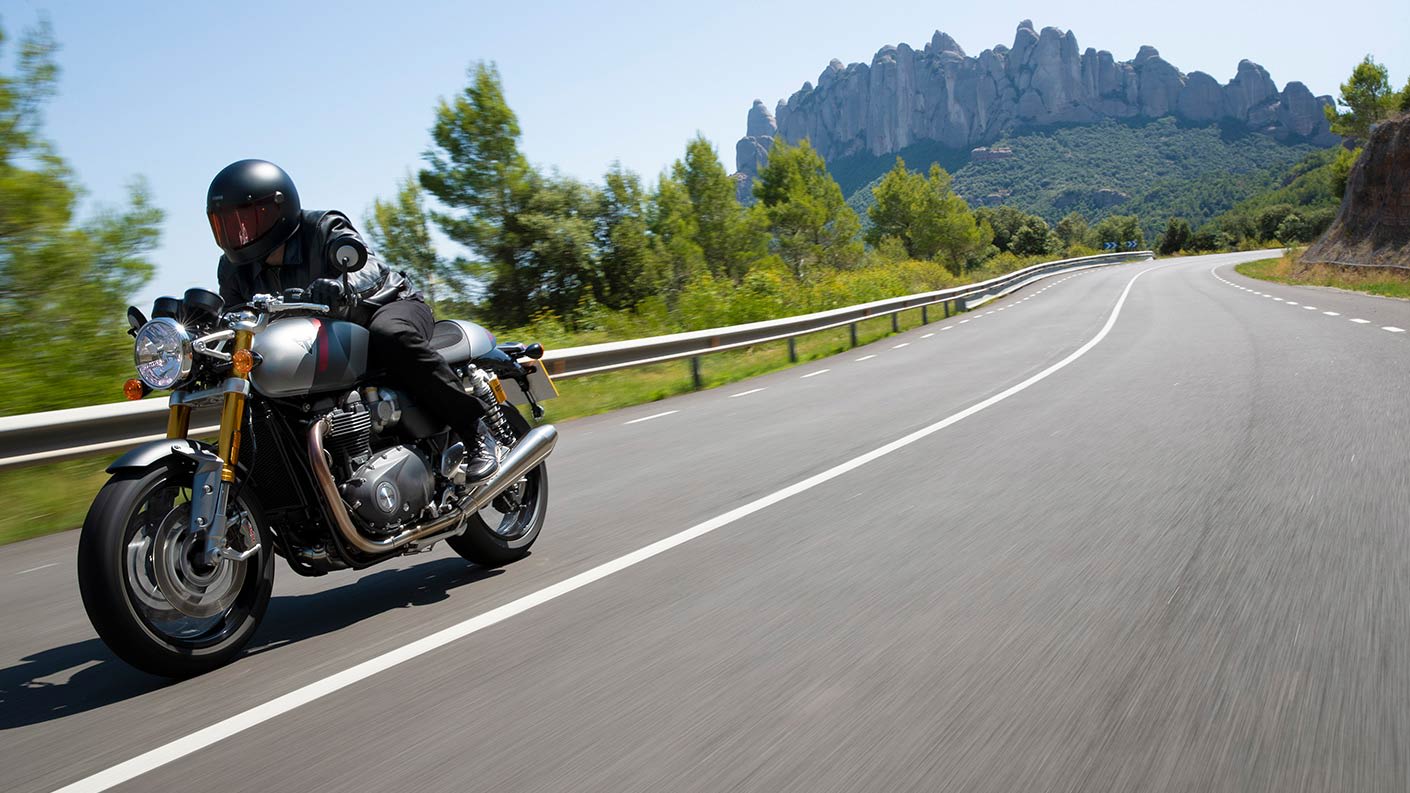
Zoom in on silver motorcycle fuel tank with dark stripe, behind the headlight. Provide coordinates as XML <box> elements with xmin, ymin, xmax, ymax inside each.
<box><xmin>250</xmin><ymin>316</ymin><xmax>368</xmax><ymax>397</ymax></box>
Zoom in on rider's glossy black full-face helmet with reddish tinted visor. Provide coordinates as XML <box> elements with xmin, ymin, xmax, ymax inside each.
<box><xmin>206</xmin><ymin>159</ymin><xmax>300</xmax><ymax>264</ymax></box>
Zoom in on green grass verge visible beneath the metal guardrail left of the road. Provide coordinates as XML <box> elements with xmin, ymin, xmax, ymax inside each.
<box><xmin>0</xmin><ymin>306</ymin><xmax>943</xmax><ymax>545</ymax></box>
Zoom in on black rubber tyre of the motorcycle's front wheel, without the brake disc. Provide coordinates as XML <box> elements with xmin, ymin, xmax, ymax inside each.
<box><xmin>78</xmin><ymin>461</ymin><xmax>275</xmax><ymax>677</ymax></box>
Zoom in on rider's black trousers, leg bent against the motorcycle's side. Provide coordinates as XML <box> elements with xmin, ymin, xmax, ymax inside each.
<box><xmin>367</xmin><ymin>298</ymin><xmax>485</xmax><ymax>447</ymax></box>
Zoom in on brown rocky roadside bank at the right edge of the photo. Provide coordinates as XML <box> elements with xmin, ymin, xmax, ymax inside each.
<box><xmin>1303</xmin><ymin>116</ymin><xmax>1410</xmax><ymax>267</ymax></box>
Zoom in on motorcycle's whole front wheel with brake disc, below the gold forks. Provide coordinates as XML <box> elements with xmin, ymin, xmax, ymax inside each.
<box><xmin>79</xmin><ymin>463</ymin><xmax>274</xmax><ymax>677</ymax></box>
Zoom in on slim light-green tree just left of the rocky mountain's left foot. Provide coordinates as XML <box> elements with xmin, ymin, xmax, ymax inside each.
<box><xmin>671</xmin><ymin>134</ymin><xmax>768</xmax><ymax>284</ymax></box>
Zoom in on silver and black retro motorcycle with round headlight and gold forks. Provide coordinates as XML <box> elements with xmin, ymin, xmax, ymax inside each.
<box><xmin>78</xmin><ymin>241</ymin><xmax>557</xmax><ymax>677</ymax></box>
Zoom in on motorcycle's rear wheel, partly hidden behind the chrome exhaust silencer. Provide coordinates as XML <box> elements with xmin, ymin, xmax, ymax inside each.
<box><xmin>446</xmin><ymin>406</ymin><xmax>548</xmax><ymax>567</ymax></box>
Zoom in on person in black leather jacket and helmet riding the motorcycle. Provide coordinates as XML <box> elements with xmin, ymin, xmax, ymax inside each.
<box><xmin>206</xmin><ymin>159</ymin><xmax>499</xmax><ymax>481</ymax></box>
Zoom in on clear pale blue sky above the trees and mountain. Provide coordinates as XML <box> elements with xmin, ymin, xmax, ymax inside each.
<box><xmin>0</xmin><ymin>0</ymin><xmax>1410</xmax><ymax>305</ymax></box>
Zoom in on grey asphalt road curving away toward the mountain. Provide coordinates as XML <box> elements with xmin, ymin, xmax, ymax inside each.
<box><xmin>0</xmin><ymin>254</ymin><xmax>1410</xmax><ymax>793</ymax></box>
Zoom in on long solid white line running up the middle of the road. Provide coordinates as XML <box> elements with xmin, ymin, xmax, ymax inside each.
<box><xmin>58</xmin><ymin>261</ymin><xmax>1153</xmax><ymax>793</ymax></box>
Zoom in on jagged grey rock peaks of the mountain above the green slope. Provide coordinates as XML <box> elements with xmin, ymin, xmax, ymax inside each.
<box><xmin>735</xmin><ymin>20</ymin><xmax>1338</xmax><ymax>193</ymax></box>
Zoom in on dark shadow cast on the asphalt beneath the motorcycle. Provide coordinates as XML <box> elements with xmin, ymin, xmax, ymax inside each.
<box><xmin>0</xmin><ymin>559</ymin><xmax>503</xmax><ymax>731</ymax></box>
